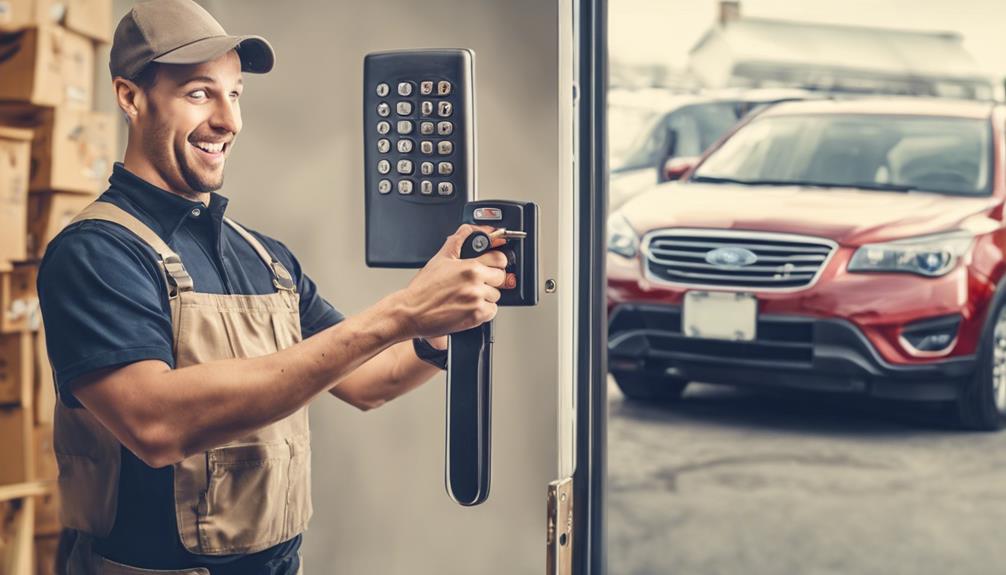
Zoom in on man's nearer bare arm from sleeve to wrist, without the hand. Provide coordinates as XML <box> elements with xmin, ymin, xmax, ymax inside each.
<box><xmin>71</xmin><ymin>299</ymin><xmax>407</xmax><ymax>467</ymax></box>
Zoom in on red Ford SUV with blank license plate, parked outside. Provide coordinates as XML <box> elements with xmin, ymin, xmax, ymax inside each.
<box><xmin>608</xmin><ymin>99</ymin><xmax>1006</xmax><ymax>429</ymax></box>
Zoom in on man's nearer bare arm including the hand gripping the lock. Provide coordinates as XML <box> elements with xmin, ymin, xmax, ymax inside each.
<box><xmin>70</xmin><ymin>225</ymin><xmax>506</xmax><ymax>467</ymax></box>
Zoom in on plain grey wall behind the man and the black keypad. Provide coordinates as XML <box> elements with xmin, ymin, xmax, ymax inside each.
<box><xmin>105</xmin><ymin>0</ymin><xmax>571</xmax><ymax>575</ymax></box>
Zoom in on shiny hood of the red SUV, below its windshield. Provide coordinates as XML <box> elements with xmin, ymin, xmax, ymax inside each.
<box><xmin>621</xmin><ymin>183</ymin><xmax>1001</xmax><ymax>245</ymax></box>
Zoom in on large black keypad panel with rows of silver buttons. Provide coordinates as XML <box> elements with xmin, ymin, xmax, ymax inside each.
<box><xmin>364</xmin><ymin>47</ymin><xmax>476</xmax><ymax>267</ymax></box>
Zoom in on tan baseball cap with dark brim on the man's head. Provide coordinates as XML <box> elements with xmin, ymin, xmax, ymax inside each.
<box><xmin>109</xmin><ymin>0</ymin><xmax>276</xmax><ymax>78</ymax></box>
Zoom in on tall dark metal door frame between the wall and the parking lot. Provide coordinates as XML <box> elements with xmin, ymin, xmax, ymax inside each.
<box><xmin>573</xmin><ymin>0</ymin><xmax>608</xmax><ymax>575</ymax></box>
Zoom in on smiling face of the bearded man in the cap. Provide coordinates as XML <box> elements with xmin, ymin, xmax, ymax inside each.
<box><xmin>138</xmin><ymin>50</ymin><xmax>242</xmax><ymax>195</ymax></box>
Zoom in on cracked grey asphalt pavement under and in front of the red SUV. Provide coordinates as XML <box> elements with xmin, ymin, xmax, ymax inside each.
<box><xmin>608</xmin><ymin>380</ymin><xmax>1006</xmax><ymax>575</ymax></box>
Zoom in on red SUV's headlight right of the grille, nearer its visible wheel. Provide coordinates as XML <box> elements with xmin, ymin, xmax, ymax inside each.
<box><xmin>849</xmin><ymin>230</ymin><xmax>975</xmax><ymax>277</ymax></box>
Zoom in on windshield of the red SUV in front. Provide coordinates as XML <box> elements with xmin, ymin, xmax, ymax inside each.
<box><xmin>692</xmin><ymin>115</ymin><xmax>992</xmax><ymax>195</ymax></box>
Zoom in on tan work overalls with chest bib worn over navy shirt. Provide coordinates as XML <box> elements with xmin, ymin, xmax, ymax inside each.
<box><xmin>54</xmin><ymin>202</ymin><xmax>312</xmax><ymax>575</ymax></box>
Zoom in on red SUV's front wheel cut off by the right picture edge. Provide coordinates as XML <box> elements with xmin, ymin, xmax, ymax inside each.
<box><xmin>957</xmin><ymin>304</ymin><xmax>1006</xmax><ymax>431</ymax></box>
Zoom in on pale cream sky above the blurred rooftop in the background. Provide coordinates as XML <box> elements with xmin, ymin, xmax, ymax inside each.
<box><xmin>608</xmin><ymin>0</ymin><xmax>1006</xmax><ymax>79</ymax></box>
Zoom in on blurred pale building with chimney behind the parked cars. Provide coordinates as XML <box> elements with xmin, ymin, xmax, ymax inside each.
<box><xmin>688</xmin><ymin>0</ymin><xmax>994</xmax><ymax>100</ymax></box>
